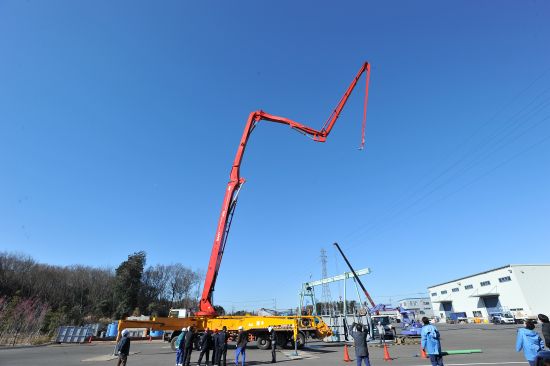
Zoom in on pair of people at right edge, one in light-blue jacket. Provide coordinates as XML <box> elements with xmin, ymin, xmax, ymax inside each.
<box><xmin>516</xmin><ymin>314</ymin><xmax>550</xmax><ymax>366</ymax></box>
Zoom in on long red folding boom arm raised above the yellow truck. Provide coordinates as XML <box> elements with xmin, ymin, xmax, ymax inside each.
<box><xmin>197</xmin><ymin>62</ymin><xmax>370</xmax><ymax>316</ymax></box>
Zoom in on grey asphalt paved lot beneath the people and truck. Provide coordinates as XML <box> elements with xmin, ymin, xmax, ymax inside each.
<box><xmin>0</xmin><ymin>324</ymin><xmax>540</xmax><ymax>366</ymax></box>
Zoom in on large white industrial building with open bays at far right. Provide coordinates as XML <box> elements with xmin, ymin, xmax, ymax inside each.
<box><xmin>428</xmin><ymin>264</ymin><xmax>550</xmax><ymax>321</ymax></box>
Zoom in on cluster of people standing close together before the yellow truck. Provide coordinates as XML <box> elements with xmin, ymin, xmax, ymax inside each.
<box><xmin>175</xmin><ymin>326</ymin><xmax>229</xmax><ymax>366</ymax></box>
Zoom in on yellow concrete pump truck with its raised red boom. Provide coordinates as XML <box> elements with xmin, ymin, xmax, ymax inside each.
<box><xmin>117</xmin><ymin>62</ymin><xmax>376</xmax><ymax>349</ymax></box>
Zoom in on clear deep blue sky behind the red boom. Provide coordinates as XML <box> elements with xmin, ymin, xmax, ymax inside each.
<box><xmin>0</xmin><ymin>1</ymin><xmax>550</xmax><ymax>308</ymax></box>
